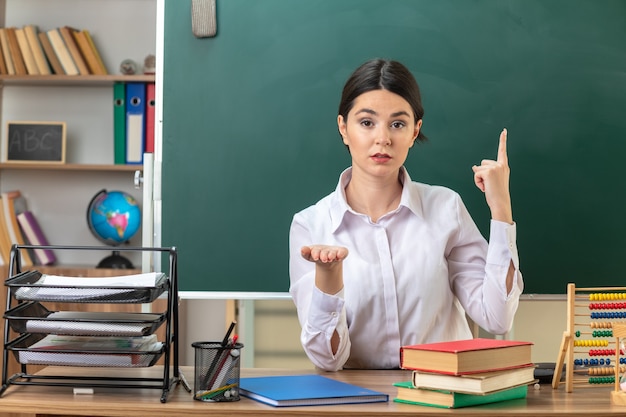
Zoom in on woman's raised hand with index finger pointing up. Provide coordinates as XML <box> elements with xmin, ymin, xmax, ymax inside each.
<box><xmin>472</xmin><ymin>129</ymin><xmax>513</xmax><ymax>224</ymax></box>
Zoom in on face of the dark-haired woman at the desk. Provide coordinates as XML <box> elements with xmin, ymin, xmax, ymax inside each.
<box><xmin>337</xmin><ymin>90</ymin><xmax>422</xmax><ymax>180</ymax></box>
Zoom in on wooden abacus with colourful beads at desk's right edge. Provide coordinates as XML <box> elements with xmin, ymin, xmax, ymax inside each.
<box><xmin>552</xmin><ymin>284</ymin><xmax>626</xmax><ymax>392</ymax></box>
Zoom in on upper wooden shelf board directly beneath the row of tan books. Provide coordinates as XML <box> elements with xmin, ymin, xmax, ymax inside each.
<box><xmin>0</xmin><ymin>74</ymin><xmax>154</xmax><ymax>87</ymax></box>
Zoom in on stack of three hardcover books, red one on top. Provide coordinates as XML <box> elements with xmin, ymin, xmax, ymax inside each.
<box><xmin>394</xmin><ymin>338</ymin><xmax>535</xmax><ymax>408</ymax></box>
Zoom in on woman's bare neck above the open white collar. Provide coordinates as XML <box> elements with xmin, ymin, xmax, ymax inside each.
<box><xmin>346</xmin><ymin>168</ymin><xmax>402</xmax><ymax>223</ymax></box>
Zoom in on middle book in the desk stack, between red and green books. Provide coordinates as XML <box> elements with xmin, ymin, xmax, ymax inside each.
<box><xmin>412</xmin><ymin>365</ymin><xmax>535</xmax><ymax>394</ymax></box>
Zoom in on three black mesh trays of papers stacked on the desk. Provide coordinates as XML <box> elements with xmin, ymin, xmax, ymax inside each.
<box><xmin>4</xmin><ymin>271</ymin><xmax>169</xmax><ymax>367</ymax></box>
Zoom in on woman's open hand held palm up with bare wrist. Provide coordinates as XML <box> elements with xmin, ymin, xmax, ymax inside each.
<box><xmin>300</xmin><ymin>245</ymin><xmax>348</xmax><ymax>294</ymax></box>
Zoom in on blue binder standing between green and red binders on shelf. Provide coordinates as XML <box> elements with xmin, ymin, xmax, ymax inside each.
<box><xmin>126</xmin><ymin>83</ymin><xmax>146</xmax><ymax>164</ymax></box>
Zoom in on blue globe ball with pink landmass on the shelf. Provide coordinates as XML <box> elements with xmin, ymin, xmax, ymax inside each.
<box><xmin>87</xmin><ymin>190</ymin><xmax>141</xmax><ymax>246</ymax></box>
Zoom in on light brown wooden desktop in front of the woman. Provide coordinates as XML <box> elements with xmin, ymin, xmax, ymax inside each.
<box><xmin>0</xmin><ymin>367</ymin><xmax>626</xmax><ymax>417</ymax></box>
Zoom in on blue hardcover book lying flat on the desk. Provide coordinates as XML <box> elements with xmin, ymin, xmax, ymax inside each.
<box><xmin>239</xmin><ymin>375</ymin><xmax>389</xmax><ymax>407</ymax></box>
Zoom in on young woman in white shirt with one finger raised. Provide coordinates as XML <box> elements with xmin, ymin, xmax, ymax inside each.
<box><xmin>289</xmin><ymin>59</ymin><xmax>523</xmax><ymax>371</ymax></box>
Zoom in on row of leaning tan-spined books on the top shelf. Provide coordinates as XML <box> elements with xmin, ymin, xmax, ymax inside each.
<box><xmin>0</xmin><ymin>24</ymin><xmax>108</xmax><ymax>75</ymax></box>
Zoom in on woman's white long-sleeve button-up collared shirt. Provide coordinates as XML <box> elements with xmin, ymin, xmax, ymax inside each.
<box><xmin>289</xmin><ymin>168</ymin><xmax>523</xmax><ymax>370</ymax></box>
